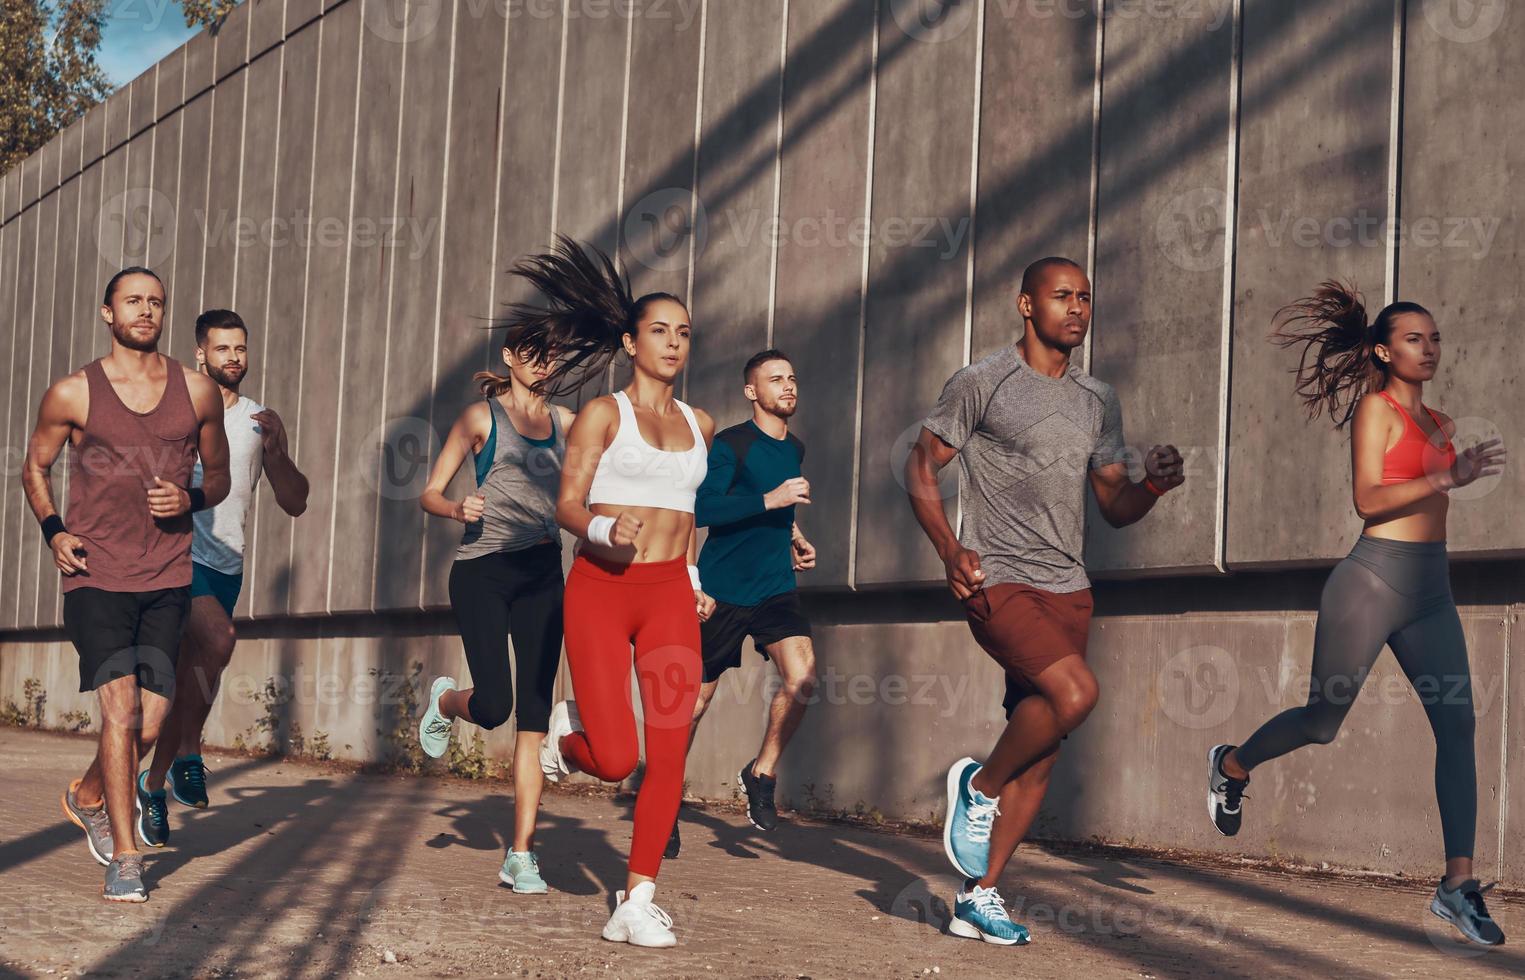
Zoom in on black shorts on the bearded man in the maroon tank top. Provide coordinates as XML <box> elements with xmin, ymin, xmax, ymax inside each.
<box><xmin>64</xmin><ymin>587</ymin><xmax>191</xmax><ymax>698</ymax></box>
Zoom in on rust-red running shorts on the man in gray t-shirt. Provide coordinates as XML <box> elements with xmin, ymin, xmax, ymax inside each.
<box><xmin>964</xmin><ymin>582</ymin><xmax>1092</xmax><ymax>718</ymax></box>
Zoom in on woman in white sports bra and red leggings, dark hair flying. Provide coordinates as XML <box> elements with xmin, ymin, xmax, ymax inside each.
<box><xmin>509</xmin><ymin>238</ymin><xmax>715</xmax><ymax>946</ymax></box>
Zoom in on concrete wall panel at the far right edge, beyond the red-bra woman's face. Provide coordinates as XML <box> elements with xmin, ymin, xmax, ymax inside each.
<box><xmin>1397</xmin><ymin>3</ymin><xmax>1525</xmax><ymax>555</ymax></box>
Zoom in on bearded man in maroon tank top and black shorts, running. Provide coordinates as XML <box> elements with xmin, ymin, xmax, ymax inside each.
<box><xmin>23</xmin><ymin>267</ymin><xmax>229</xmax><ymax>902</ymax></box>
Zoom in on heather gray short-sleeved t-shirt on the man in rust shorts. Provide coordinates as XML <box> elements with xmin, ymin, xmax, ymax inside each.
<box><xmin>923</xmin><ymin>344</ymin><xmax>1125</xmax><ymax>593</ymax></box>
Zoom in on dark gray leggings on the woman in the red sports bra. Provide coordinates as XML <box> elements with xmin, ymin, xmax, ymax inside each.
<box><xmin>1235</xmin><ymin>535</ymin><xmax>1478</xmax><ymax>860</ymax></box>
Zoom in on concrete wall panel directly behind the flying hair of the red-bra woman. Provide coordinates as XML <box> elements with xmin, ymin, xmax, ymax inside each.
<box><xmin>1226</xmin><ymin>0</ymin><xmax>1394</xmax><ymax>567</ymax></box>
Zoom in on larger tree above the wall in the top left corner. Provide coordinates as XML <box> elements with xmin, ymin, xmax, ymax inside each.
<box><xmin>0</xmin><ymin>0</ymin><xmax>111</xmax><ymax>172</ymax></box>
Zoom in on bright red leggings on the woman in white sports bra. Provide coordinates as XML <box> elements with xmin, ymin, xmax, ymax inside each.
<box><xmin>561</xmin><ymin>555</ymin><xmax>702</xmax><ymax>878</ymax></box>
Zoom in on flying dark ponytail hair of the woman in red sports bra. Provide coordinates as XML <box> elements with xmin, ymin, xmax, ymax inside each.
<box><xmin>1270</xmin><ymin>279</ymin><xmax>1430</xmax><ymax>428</ymax></box>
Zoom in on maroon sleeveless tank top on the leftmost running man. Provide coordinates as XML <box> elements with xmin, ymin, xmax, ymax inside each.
<box><xmin>63</xmin><ymin>355</ymin><xmax>198</xmax><ymax>593</ymax></box>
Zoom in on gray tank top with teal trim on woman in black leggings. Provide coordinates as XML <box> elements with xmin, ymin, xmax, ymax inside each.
<box><xmin>456</xmin><ymin>398</ymin><xmax>567</xmax><ymax>559</ymax></box>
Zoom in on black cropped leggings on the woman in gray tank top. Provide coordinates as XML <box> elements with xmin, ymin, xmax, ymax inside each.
<box><xmin>450</xmin><ymin>543</ymin><xmax>563</xmax><ymax>732</ymax></box>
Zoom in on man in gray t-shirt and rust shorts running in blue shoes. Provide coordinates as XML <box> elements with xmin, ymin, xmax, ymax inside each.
<box><xmin>906</xmin><ymin>258</ymin><xmax>1183</xmax><ymax>945</ymax></box>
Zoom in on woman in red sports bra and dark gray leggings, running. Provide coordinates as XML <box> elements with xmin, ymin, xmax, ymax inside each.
<box><xmin>1208</xmin><ymin>282</ymin><xmax>1504</xmax><ymax>945</ymax></box>
